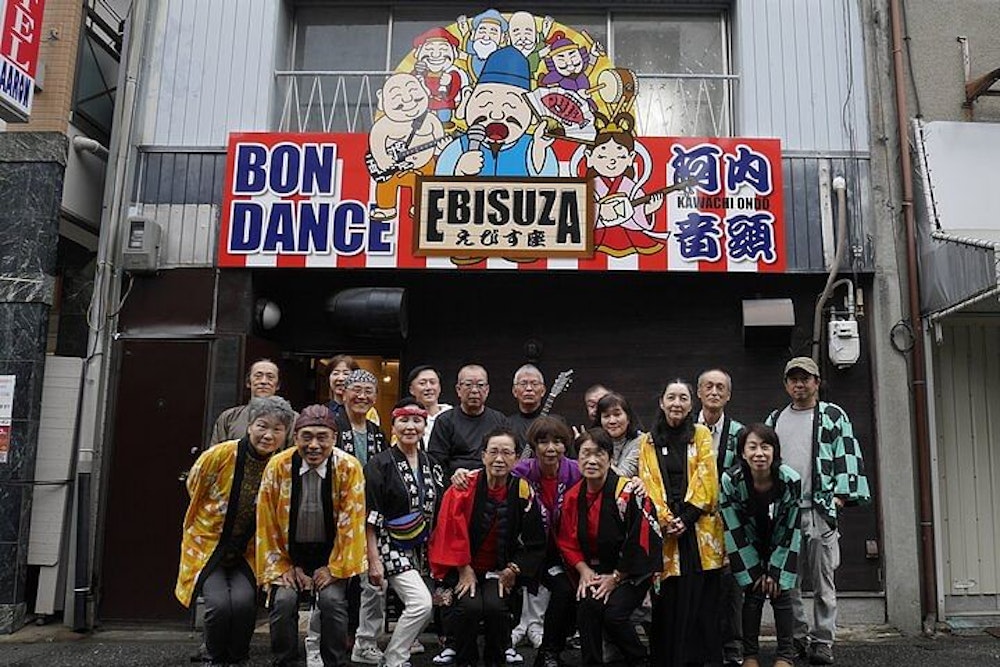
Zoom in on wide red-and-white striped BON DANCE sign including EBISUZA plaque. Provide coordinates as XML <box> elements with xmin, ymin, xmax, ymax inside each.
<box><xmin>218</xmin><ymin>133</ymin><xmax>786</xmax><ymax>272</ymax></box>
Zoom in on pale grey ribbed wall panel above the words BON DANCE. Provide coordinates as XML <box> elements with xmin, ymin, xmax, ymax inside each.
<box><xmin>137</xmin><ymin>0</ymin><xmax>288</xmax><ymax>146</ymax></box>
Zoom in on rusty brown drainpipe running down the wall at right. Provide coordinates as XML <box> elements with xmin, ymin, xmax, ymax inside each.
<box><xmin>889</xmin><ymin>0</ymin><xmax>937</xmax><ymax>634</ymax></box>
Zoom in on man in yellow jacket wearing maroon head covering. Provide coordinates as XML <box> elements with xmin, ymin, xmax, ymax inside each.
<box><xmin>257</xmin><ymin>405</ymin><xmax>366</xmax><ymax>667</ymax></box>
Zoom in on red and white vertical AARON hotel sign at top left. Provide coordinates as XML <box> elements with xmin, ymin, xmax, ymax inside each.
<box><xmin>0</xmin><ymin>0</ymin><xmax>45</xmax><ymax>122</ymax></box>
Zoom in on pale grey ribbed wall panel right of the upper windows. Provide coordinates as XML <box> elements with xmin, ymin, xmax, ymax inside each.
<box><xmin>733</xmin><ymin>0</ymin><xmax>869</xmax><ymax>153</ymax></box>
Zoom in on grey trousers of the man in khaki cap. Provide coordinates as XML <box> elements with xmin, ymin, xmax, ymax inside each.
<box><xmin>791</xmin><ymin>509</ymin><xmax>840</xmax><ymax>645</ymax></box>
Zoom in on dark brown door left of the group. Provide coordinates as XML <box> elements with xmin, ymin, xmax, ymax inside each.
<box><xmin>99</xmin><ymin>341</ymin><xmax>211</xmax><ymax>620</ymax></box>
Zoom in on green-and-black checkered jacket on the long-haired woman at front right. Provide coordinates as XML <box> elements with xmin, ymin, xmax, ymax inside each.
<box><xmin>720</xmin><ymin>465</ymin><xmax>802</xmax><ymax>590</ymax></box>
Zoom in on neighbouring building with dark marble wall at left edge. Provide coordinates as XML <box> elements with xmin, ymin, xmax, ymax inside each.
<box><xmin>0</xmin><ymin>0</ymin><xmax>124</xmax><ymax>632</ymax></box>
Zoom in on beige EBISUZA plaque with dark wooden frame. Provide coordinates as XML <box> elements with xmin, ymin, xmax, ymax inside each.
<box><xmin>413</xmin><ymin>177</ymin><xmax>594</xmax><ymax>260</ymax></box>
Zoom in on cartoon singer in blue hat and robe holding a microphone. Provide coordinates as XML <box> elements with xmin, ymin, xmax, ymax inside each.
<box><xmin>435</xmin><ymin>46</ymin><xmax>559</xmax><ymax>177</ymax></box>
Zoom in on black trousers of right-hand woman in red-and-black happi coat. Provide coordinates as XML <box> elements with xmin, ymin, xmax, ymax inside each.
<box><xmin>576</xmin><ymin>579</ymin><xmax>649</xmax><ymax>667</ymax></box>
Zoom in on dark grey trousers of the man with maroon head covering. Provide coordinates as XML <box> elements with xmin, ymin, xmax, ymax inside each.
<box><xmin>269</xmin><ymin>579</ymin><xmax>347</xmax><ymax>667</ymax></box>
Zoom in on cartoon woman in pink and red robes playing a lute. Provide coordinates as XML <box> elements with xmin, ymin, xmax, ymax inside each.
<box><xmin>584</xmin><ymin>112</ymin><xmax>667</xmax><ymax>257</ymax></box>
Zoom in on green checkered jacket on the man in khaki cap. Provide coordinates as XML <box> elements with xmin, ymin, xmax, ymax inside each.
<box><xmin>765</xmin><ymin>401</ymin><xmax>871</xmax><ymax>528</ymax></box>
